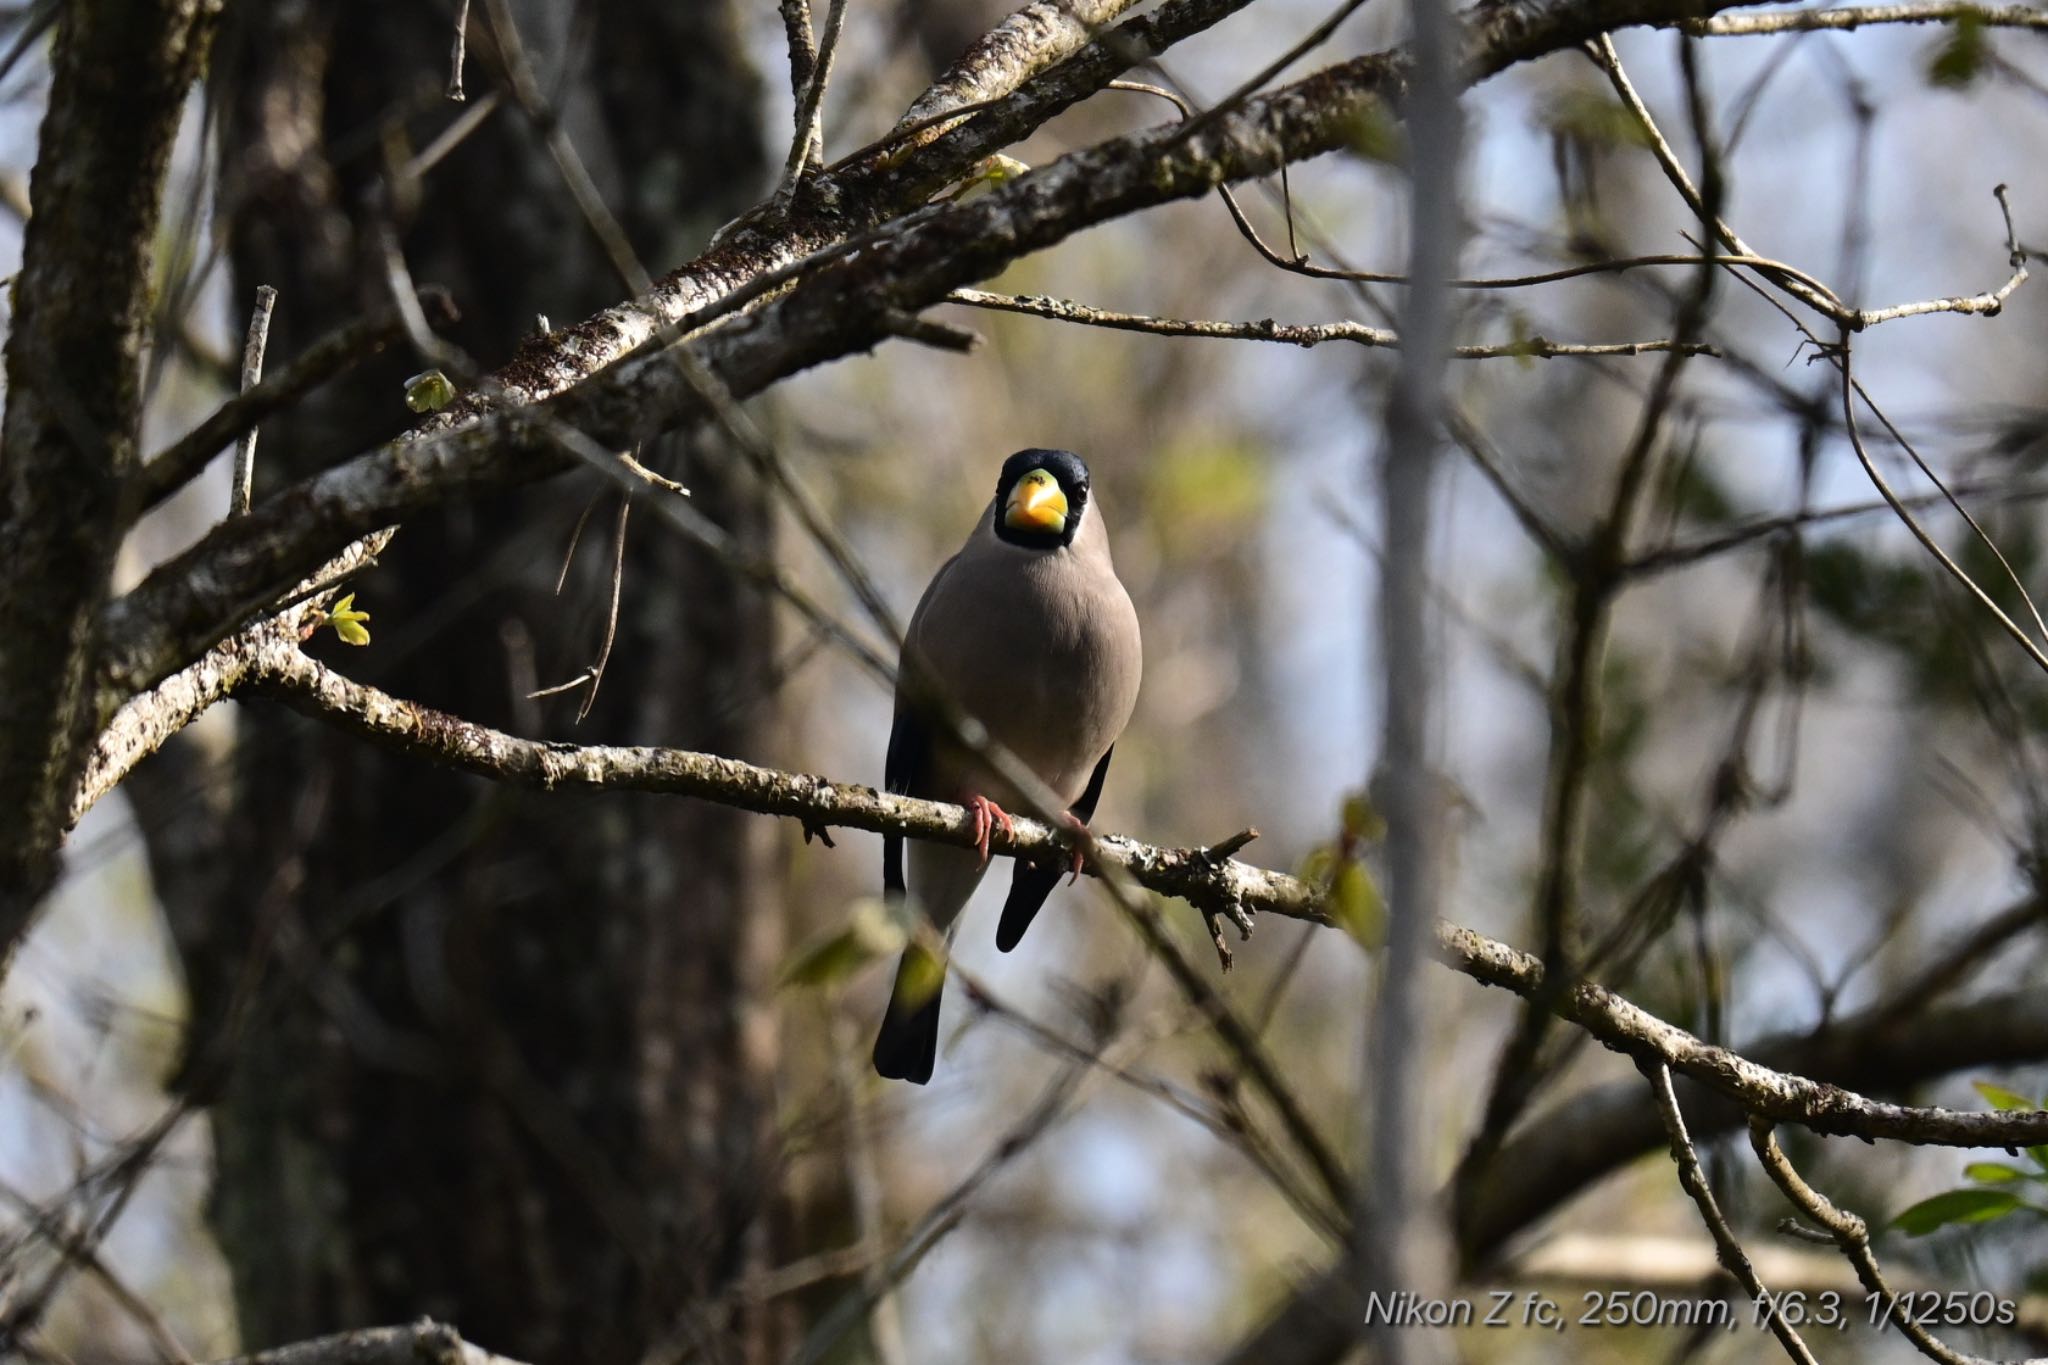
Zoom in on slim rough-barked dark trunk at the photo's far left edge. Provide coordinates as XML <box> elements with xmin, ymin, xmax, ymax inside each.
<box><xmin>0</xmin><ymin>0</ymin><xmax>219</xmax><ymax>941</ymax></box>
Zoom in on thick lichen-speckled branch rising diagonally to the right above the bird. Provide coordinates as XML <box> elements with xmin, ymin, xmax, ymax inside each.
<box><xmin>102</xmin><ymin>0</ymin><xmax>1835</xmax><ymax>716</ymax></box>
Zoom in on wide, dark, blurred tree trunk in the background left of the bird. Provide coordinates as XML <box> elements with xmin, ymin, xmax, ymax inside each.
<box><xmin>137</xmin><ymin>0</ymin><xmax>780</xmax><ymax>1361</ymax></box>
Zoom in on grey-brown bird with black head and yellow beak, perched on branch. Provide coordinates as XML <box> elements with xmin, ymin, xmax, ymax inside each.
<box><xmin>874</xmin><ymin>450</ymin><xmax>1143</xmax><ymax>1085</ymax></box>
